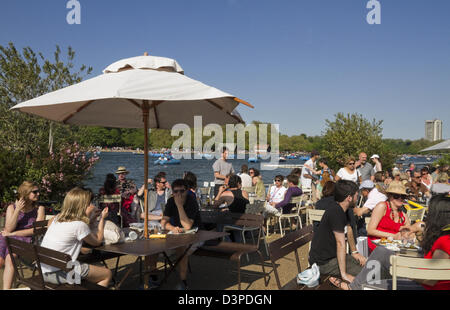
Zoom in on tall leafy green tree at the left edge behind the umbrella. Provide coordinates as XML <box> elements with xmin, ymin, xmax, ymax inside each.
<box><xmin>0</xmin><ymin>43</ymin><xmax>92</xmax><ymax>202</ymax></box>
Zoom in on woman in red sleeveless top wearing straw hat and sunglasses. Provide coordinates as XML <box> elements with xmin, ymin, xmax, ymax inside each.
<box><xmin>367</xmin><ymin>181</ymin><xmax>416</xmax><ymax>252</ymax></box>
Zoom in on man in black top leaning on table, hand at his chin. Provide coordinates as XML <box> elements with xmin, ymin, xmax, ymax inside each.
<box><xmin>161</xmin><ymin>179</ymin><xmax>201</xmax><ymax>289</ymax></box>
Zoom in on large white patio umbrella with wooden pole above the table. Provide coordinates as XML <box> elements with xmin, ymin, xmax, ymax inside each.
<box><xmin>12</xmin><ymin>53</ymin><xmax>253</xmax><ymax>237</ymax></box>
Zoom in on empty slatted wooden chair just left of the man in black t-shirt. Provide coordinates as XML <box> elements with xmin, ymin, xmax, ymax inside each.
<box><xmin>269</xmin><ymin>225</ymin><xmax>336</xmax><ymax>290</ymax></box>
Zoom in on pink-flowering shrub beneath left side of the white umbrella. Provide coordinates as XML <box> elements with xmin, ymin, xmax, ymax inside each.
<box><xmin>40</xmin><ymin>142</ymin><xmax>99</xmax><ymax>202</ymax></box>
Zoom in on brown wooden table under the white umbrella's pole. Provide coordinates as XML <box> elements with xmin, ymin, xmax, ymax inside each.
<box><xmin>96</xmin><ymin>230</ymin><xmax>228</xmax><ymax>288</ymax></box>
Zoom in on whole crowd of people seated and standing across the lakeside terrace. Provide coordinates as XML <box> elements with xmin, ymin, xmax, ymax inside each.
<box><xmin>0</xmin><ymin>151</ymin><xmax>450</xmax><ymax>290</ymax></box>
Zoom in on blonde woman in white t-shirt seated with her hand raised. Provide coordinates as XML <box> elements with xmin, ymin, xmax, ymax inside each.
<box><xmin>41</xmin><ymin>188</ymin><xmax>112</xmax><ymax>287</ymax></box>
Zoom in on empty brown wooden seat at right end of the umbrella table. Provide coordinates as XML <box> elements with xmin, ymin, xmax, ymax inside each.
<box><xmin>193</xmin><ymin>211</ymin><xmax>268</xmax><ymax>290</ymax></box>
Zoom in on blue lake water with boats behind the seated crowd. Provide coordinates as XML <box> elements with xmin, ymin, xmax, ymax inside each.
<box><xmin>85</xmin><ymin>152</ymin><xmax>304</xmax><ymax>193</ymax></box>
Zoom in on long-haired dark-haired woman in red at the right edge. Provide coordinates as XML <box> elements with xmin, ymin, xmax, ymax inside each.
<box><xmin>330</xmin><ymin>194</ymin><xmax>450</xmax><ymax>290</ymax></box>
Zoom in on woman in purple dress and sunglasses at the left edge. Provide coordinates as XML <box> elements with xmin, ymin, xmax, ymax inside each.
<box><xmin>0</xmin><ymin>181</ymin><xmax>45</xmax><ymax>290</ymax></box>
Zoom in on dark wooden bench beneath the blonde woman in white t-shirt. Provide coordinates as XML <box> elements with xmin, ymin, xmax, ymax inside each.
<box><xmin>6</xmin><ymin>237</ymin><xmax>106</xmax><ymax>290</ymax></box>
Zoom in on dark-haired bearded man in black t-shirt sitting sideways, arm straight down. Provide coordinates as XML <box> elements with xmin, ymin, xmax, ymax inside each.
<box><xmin>309</xmin><ymin>180</ymin><xmax>366</xmax><ymax>282</ymax></box>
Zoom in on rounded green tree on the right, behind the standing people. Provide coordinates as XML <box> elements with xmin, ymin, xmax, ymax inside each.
<box><xmin>321</xmin><ymin>113</ymin><xmax>393</xmax><ymax>170</ymax></box>
